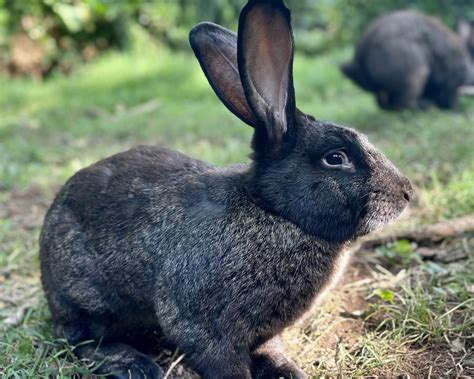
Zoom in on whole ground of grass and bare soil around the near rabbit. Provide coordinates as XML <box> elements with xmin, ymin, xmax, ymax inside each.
<box><xmin>0</xmin><ymin>31</ymin><xmax>474</xmax><ymax>378</ymax></box>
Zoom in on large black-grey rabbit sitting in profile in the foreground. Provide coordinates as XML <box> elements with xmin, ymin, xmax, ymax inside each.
<box><xmin>40</xmin><ymin>0</ymin><xmax>412</xmax><ymax>379</ymax></box>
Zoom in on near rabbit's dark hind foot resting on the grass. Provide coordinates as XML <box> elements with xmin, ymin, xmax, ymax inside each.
<box><xmin>75</xmin><ymin>343</ymin><xmax>163</xmax><ymax>379</ymax></box>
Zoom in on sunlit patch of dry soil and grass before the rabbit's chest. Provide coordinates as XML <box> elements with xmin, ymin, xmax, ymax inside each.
<box><xmin>287</xmin><ymin>237</ymin><xmax>474</xmax><ymax>378</ymax></box>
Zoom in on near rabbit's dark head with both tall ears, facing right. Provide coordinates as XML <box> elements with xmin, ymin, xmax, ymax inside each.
<box><xmin>190</xmin><ymin>0</ymin><xmax>412</xmax><ymax>242</ymax></box>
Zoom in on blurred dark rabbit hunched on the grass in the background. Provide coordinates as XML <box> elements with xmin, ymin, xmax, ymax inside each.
<box><xmin>341</xmin><ymin>11</ymin><xmax>474</xmax><ymax>110</ymax></box>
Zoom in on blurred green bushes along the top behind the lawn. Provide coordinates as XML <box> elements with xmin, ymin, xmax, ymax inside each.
<box><xmin>0</xmin><ymin>0</ymin><xmax>474</xmax><ymax>78</ymax></box>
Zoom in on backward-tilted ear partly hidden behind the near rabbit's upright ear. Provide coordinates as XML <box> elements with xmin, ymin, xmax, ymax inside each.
<box><xmin>189</xmin><ymin>22</ymin><xmax>257</xmax><ymax>127</ymax></box>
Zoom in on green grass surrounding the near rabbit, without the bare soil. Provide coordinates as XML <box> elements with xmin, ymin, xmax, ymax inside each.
<box><xmin>0</xmin><ymin>29</ymin><xmax>474</xmax><ymax>378</ymax></box>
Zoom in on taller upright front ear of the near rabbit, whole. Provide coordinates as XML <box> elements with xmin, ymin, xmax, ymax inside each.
<box><xmin>237</xmin><ymin>0</ymin><xmax>296</xmax><ymax>149</ymax></box>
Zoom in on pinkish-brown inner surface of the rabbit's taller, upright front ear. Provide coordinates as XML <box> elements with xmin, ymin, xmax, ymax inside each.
<box><xmin>245</xmin><ymin>5</ymin><xmax>292</xmax><ymax>112</ymax></box>
